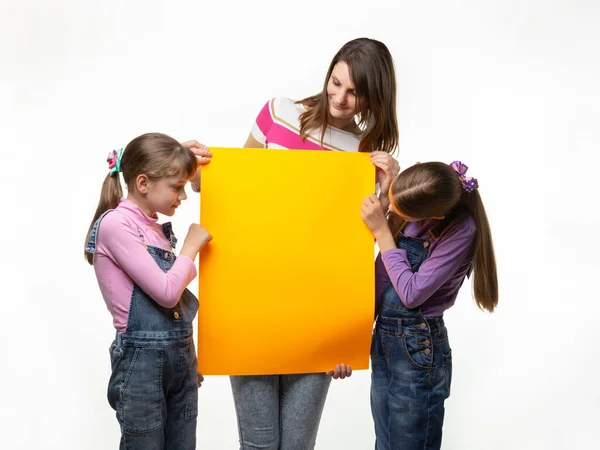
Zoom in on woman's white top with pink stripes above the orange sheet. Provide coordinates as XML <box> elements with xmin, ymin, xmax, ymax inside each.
<box><xmin>252</xmin><ymin>97</ymin><xmax>360</xmax><ymax>152</ymax></box>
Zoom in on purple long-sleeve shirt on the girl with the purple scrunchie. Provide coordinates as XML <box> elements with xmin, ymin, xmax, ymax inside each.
<box><xmin>375</xmin><ymin>213</ymin><xmax>476</xmax><ymax>317</ymax></box>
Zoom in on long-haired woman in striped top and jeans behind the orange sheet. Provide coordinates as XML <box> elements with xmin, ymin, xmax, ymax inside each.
<box><xmin>231</xmin><ymin>38</ymin><xmax>399</xmax><ymax>450</ymax></box>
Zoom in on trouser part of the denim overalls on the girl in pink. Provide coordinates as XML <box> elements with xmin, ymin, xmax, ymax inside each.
<box><xmin>107</xmin><ymin>330</ymin><xmax>198</xmax><ymax>450</ymax></box>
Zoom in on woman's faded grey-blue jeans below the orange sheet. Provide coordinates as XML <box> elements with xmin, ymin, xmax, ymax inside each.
<box><xmin>231</xmin><ymin>373</ymin><xmax>331</xmax><ymax>450</ymax></box>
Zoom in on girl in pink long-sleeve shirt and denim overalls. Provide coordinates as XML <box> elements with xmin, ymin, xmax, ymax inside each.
<box><xmin>85</xmin><ymin>133</ymin><xmax>211</xmax><ymax>450</ymax></box>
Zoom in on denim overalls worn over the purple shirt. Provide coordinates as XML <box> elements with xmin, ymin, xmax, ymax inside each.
<box><xmin>371</xmin><ymin>217</ymin><xmax>452</xmax><ymax>450</ymax></box>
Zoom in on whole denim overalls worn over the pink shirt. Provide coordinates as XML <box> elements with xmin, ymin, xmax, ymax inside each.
<box><xmin>86</xmin><ymin>211</ymin><xmax>198</xmax><ymax>450</ymax></box>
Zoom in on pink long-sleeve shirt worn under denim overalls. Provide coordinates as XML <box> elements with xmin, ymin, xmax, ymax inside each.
<box><xmin>94</xmin><ymin>198</ymin><xmax>196</xmax><ymax>331</ymax></box>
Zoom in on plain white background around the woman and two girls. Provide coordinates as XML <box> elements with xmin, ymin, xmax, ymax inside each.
<box><xmin>0</xmin><ymin>0</ymin><xmax>600</xmax><ymax>450</ymax></box>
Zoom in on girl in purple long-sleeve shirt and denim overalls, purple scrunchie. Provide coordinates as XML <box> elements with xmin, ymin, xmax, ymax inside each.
<box><xmin>361</xmin><ymin>161</ymin><xmax>498</xmax><ymax>450</ymax></box>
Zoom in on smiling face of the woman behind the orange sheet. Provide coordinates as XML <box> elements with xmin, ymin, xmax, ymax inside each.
<box><xmin>327</xmin><ymin>61</ymin><xmax>356</xmax><ymax>128</ymax></box>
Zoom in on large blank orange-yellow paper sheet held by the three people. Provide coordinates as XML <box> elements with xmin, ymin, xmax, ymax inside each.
<box><xmin>198</xmin><ymin>148</ymin><xmax>375</xmax><ymax>375</ymax></box>
